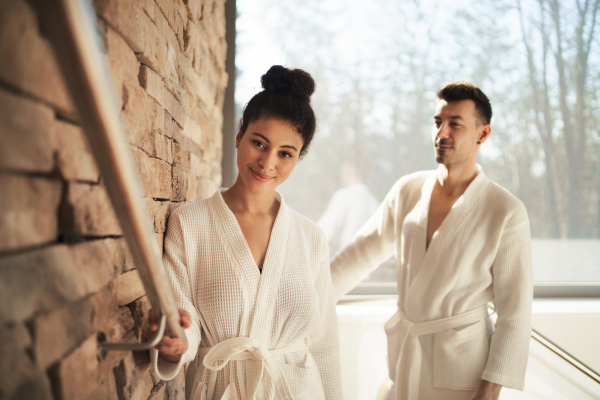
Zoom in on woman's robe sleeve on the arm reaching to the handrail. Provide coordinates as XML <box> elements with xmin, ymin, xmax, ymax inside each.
<box><xmin>150</xmin><ymin>212</ymin><xmax>200</xmax><ymax>381</ymax></box>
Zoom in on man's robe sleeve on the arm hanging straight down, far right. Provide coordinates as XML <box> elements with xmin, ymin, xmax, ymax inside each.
<box><xmin>482</xmin><ymin>202</ymin><xmax>533</xmax><ymax>390</ymax></box>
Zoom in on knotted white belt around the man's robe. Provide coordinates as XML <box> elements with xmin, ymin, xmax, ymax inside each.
<box><xmin>385</xmin><ymin>304</ymin><xmax>489</xmax><ymax>400</ymax></box>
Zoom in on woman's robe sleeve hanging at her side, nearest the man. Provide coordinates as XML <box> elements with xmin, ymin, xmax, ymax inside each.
<box><xmin>309</xmin><ymin>231</ymin><xmax>342</xmax><ymax>400</ymax></box>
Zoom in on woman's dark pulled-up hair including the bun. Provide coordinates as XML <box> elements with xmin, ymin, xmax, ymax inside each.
<box><xmin>239</xmin><ymin>65</ymin><xmax>317</xmax><ymax>157</ymax></box>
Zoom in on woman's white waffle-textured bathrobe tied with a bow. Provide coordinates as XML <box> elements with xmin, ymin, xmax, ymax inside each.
<box><xmin>151</xmin><ymin>191</ymin><xmax>342</xmax><ymax>400</ymax></box>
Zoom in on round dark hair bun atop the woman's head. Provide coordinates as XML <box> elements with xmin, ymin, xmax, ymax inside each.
<box><xmin>260</xmin><ymin>65</ymin><xmax>315</xmax><ymax>97</ymax></box>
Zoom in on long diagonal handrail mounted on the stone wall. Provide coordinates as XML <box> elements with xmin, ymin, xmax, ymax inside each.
<box><xmin>33</xmin><ymin>0</ymin><xmax>186</xmax><ymax>349</ymax></box>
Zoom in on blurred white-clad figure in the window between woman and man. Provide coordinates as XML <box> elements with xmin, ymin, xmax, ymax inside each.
<box><xmin>317</xmin><ymin>161</ymin><xmax>379</xmax><ymax>254</ymax></box>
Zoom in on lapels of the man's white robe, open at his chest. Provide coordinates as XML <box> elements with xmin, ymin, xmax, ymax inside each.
<box><xmin>405</xmin><ymin>165</ymin><xmax>489</xmax><ymax>322</ymax></box>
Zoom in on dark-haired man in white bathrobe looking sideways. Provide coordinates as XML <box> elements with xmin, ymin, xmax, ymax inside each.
<box><xmin>331</xmin><ymin>82</ymin><xmax>533</xmax><ymax>400</ymax></box>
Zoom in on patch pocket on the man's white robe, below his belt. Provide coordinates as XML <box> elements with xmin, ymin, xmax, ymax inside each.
<box><xmin>433</xmin><ymin>319</ymin><xmax>490</xmax><ymax>390</ymax></box>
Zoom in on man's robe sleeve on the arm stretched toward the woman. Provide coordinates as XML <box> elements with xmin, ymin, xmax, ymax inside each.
<box><xmin>331</xmin><ymin>179</ymin><xmax>402</xmax><ymax>302</ymax></box>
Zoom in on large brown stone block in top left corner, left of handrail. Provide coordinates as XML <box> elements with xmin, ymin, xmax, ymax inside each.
<box><xmin>0</xmin><ymin>0</ymin><xmax>75</xmax><ymax>117</ymax></box>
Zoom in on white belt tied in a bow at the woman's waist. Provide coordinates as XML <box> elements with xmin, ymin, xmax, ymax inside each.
<box><xmin>193</xmin><ymin>337</ymin><xmax>310</xmax><ymax>400</ymax></box>
